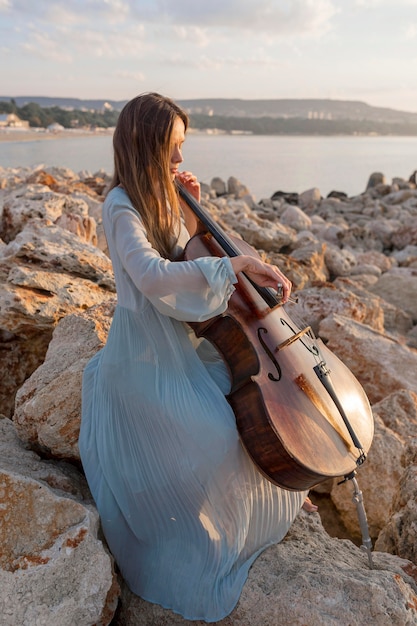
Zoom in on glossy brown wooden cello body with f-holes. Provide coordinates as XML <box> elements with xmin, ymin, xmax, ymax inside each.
<box><xmin>180</xmin><ymin>183</ymin><xmax>374</xmax><ymax>491</ymax></box>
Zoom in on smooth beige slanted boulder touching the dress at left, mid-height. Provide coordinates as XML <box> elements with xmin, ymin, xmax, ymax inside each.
<box><xmin>13</xmin><ymin>302</ymin><xmax>114</xmax><ymax>460</ymax></box>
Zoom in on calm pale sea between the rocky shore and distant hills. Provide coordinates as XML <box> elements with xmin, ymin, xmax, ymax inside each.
<box><xmin>0</xmin><ymin>133</ymin><xmax>417</xmax><ymax>199</ymax></box>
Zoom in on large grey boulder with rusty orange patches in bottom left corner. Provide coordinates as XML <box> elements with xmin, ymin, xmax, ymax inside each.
<box><xmin>0</xmin><ymin>418</ymin><xmax>119</xmax><ymax>626</ymax></box>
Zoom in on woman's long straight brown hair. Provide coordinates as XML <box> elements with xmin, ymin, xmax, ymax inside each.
<box><xmin>110</xmin><ymin>93</ymin><xmax>188</xmax><ymax>258</ymax></box>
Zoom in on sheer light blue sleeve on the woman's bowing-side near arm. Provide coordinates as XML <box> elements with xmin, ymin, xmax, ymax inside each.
<box><xmin>103</xmin><ymin>191</ymin><xmax>237</xmax><ymax>322</ymax></box>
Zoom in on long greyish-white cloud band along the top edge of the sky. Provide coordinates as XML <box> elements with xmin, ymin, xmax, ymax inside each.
<box><xmin>4</xmin><ymin>0</ymin><xmax>337</xmax><ymax>36</ymax></box>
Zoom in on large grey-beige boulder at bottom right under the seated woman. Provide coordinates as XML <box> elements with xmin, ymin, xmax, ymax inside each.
<box><xmin>114</xmin><ymin>511</ymin><xmax>417</xmax><ymax>626</ymax></box>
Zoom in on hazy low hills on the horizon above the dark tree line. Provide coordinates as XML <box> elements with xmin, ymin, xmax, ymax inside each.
<box><xmin>0</xmin><ymin>96</ymin><xmax>417</xmax><ymax>124</ymax></box>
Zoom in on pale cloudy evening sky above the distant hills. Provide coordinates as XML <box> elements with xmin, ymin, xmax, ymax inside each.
<box><xmin>0</xmin><ymin>0</ymin><xmax>417</xmax><ymax>112</ymax></box>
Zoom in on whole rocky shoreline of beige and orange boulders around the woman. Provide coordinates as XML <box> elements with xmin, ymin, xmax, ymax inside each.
<box><xmin>0</xmin><ymin>166</ymin><xmax>417</xmax><ymax>626</ymax></box>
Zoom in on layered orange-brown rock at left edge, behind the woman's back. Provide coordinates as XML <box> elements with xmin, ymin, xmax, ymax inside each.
<box><xmin>0</xmin><ymin>212</ymin><xmax>114</xmax><ymax>416</ymax></box>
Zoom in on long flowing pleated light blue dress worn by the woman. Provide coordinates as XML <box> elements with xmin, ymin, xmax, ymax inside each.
<box><xmin>79</xmin><ymin>188</ymin><xmax>306</xmax><ymax>622</ymax></box>
